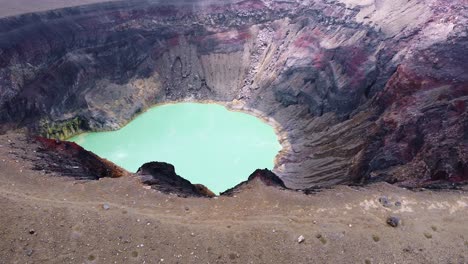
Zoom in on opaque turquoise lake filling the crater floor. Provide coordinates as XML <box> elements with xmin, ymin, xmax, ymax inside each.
<box><xmin>70</xmin><ymin>103</ymin><xmax>281</xmax><ymax>193</ymax></box>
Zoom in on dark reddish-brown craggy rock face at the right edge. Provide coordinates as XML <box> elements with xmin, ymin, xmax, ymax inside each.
<box><xmin>370</xmin><ymin>67</ymin><xmax>468</xmax><ymax>186</ymax></box>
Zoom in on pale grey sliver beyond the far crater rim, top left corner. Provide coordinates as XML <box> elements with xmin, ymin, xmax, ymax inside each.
<box><xmin>0</xmin><ymin>0</ymin><xmax>118</xmax><ymax>18</ymax></box>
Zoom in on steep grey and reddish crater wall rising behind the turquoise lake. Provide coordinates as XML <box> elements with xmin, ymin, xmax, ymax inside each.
<box><xmin>0</xmin><ymin>0</ymin><xmax>468</xmax><ymax>189</ymax></box>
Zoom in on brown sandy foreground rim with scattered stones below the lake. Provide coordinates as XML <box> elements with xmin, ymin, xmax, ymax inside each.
<box><xmin>0</xmin><ymin>134</ymin><xmax>468</xmax><ymax>264</ymax></box>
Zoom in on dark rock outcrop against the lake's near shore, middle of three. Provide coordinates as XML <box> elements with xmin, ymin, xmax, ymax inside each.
<box><xmin>136</xmin><ymin>162</ymin><xmax>215</xmax><ymax>197</ymax></box>
